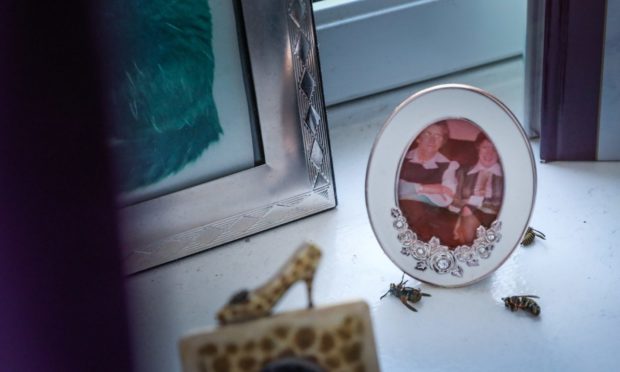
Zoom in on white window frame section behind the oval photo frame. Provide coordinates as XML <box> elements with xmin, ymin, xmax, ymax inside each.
<box><xmin>314</xmin><ymin>0</ymin><xmax>527</xmax><ymax>105</ymax></box>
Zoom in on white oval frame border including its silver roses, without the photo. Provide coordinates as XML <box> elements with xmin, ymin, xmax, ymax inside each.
<box><xmin>366</xmin><ymin>84</ymin><xmax>536</xmax><ymax>288</ymax></box>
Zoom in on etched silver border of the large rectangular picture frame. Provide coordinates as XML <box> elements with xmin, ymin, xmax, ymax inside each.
<box><xmin>119</xmin><ymin>0</ymin><xmax>336</xmax><ymax>274</ymax></box>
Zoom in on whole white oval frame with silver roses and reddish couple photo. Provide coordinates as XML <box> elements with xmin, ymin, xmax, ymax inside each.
<box><xmin>366</xmin><ymin>84</ymin><xmax>536</xmax><ymax>287</ymax></box>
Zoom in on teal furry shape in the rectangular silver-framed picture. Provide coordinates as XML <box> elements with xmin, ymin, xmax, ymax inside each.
<box><xmin>98</xmin><ymin>0</ymin><xmax>222</xmax><ymax>192</ymax></box>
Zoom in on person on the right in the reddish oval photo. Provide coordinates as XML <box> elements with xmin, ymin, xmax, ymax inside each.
<box><xmin>450</xmin><ymin>133</ymin><xmax>504</xmax><ymax>244</ymax></box>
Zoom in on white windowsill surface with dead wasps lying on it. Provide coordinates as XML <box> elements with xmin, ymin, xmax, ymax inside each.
<box><xmin>127</xmin><ymin>60</ymin><xmax>620</xmax><ymax>372</ymax></box>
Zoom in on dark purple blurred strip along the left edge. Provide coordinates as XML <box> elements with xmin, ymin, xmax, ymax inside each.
<box><xmin>0</xmin><ymin>0</ymin><xmax>131</xmax><ymax>371</ymax></box>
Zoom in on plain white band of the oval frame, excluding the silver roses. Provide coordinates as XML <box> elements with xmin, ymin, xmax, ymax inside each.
<box><xmin>366</xmin><ymin>84</ymin><xmax>536</xmax><ymax>287</ymax></box>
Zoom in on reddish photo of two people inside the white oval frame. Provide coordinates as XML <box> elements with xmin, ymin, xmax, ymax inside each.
<box><xmin>395</xmin><ymin>118</ymin><xmax>504</xmax><ymax>250</ymax></box>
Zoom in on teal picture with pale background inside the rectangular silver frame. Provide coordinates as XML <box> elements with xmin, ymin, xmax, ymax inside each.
<box><xmin>98</xmin><ymin>0</ymin><xmax>263</xmax><ymax>206</ymax></box>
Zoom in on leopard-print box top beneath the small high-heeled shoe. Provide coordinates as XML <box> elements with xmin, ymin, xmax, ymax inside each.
<box><xmin>180</xmin><ymin>302</ymin><xmax>379</xmax><ymax>372</ymax></box>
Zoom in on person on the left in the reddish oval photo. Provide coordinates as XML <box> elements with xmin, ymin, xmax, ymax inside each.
<box><xmin>398</xmin><ymin>122</ymin><xmax>459</xmax><ymax>245</ymax></box>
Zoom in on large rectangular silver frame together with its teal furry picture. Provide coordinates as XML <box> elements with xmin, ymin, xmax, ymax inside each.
<box><xmin>96</xmin><ymin>0</ymin><xmax>336</xmax><ymax>273</ymax></box>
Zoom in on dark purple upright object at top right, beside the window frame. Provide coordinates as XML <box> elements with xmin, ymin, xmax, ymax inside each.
<box><xmin>525</xmin><ymin>0</ymin><xmax>620</xmax><ymax>161</ymax></box>
